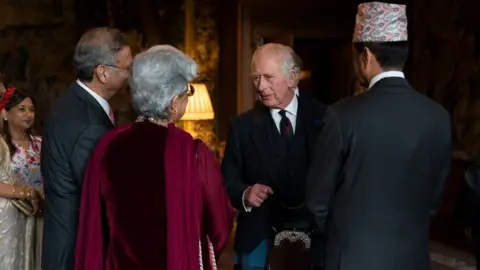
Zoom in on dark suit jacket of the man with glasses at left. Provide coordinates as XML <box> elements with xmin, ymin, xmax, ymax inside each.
<box><xmin>41</xmin><ymin>83</ymin><xmax>113</xmax><ymax>270</ymax></box>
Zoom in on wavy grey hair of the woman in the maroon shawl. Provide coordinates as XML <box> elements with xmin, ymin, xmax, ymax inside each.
<box><xmin>130</xmin><ymin>45</ymin><xmax>197</xmax><ymax>119</ymax></box>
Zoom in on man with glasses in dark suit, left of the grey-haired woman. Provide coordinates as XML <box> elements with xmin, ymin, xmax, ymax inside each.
<box><xmin>41</xmin><ymin>28</ymin><xmax>132</xmax><ymax>270</ymax></box>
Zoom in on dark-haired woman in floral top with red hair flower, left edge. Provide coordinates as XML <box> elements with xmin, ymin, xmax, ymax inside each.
<box><xmin>0</xmin><ymin>88</ymin><xmax>43</xmax><ymax>270</ymax></box>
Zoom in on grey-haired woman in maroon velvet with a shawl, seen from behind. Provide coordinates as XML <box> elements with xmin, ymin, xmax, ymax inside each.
<box><xmin>75</xmin><ymin>45</ymin><xmax>233</xmax><ymax>270</ymax></box>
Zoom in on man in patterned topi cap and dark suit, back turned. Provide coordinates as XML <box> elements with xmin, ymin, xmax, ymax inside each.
<box><xmin>306</xmin><ymin>2</ymin><xmax>451</xmax><ymax>270</ymax></box>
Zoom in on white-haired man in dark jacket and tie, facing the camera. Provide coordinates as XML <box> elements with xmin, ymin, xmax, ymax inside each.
<box><xmin>222</xmin><ymin>43</ymin><xmax>326</xmax><ymax>270</ymax></box>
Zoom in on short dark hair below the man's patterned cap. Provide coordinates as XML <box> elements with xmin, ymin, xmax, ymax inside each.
<box><xmin>353</xmin><ymin>41</ymin><xmax>409</xmax><ymax>70</ymax></box>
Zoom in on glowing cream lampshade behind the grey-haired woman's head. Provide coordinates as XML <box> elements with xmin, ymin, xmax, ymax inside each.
<box><xmin>181</xmin><ymin>83</ymin><xmax>215</xmax><ymax>120</ymax></box>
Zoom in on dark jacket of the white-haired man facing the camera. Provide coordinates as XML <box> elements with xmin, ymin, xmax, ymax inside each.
<box><xmin>222</xmin><ymin>94</ymin><xmax>327</xmax><ymax>252</ymax></box>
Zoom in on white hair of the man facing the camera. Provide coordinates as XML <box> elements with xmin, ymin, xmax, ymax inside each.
<box><xmin>252</xmin><ymin>43</ymin><xmax>302</xmax><ymax>83</ymax></box>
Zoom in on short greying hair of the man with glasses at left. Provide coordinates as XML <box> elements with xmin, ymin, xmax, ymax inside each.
<box><xmin>73</xmin><ymin>27</ymin><xmax>126</xmax><ymax>82</ymax></box>
